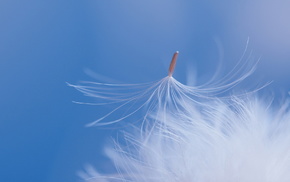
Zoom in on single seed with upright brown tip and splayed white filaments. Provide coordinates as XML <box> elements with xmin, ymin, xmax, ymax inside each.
<box><xmin>69</xmin><ymin>51</ymin><xmax>255</xmax><ymax>126</ymax></box>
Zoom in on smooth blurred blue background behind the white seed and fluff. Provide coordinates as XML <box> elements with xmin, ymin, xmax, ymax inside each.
<box><xmin>0</xmin><ymin>0</ymin><xmax>290</xmax><ymax>182</ymax></box>
